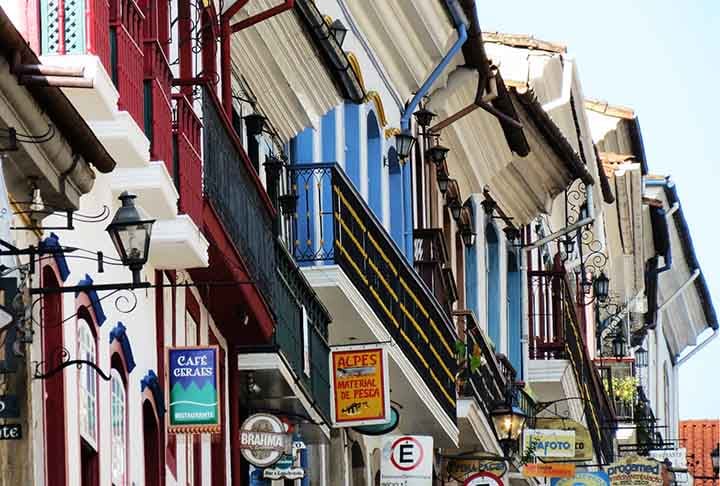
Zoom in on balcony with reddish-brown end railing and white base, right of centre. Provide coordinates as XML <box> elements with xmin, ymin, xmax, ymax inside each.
<box><xmin>528</xmin><ymin>271</ymin><xmax>616</xmax><ymax>462</ymax></box>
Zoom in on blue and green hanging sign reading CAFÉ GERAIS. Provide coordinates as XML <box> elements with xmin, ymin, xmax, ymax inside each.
<box><xmin>167</xmin><ymin>346</ymin><xmax>220</xmax><ymax>434</ymax></box>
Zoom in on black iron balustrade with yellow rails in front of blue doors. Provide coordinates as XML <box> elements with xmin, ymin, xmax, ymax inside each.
<box><xmin>288</xmin><ymin>164</ymin><xmax>457</xmax><ymax>420</ymax></box>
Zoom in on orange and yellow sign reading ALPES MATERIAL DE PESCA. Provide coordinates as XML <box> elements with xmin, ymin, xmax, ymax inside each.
<box><xmin>330</xmin><ymin>345</ymin><xmax>390</xmax><ymax>427</ymax></box>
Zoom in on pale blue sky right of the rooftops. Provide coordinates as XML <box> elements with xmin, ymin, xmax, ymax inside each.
<box><xmin>477</xmin><ymin>0</ymin><xmax>720</xmax><ymax>418</ymax></box>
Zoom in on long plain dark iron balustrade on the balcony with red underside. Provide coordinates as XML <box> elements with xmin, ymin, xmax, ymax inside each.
<box><xmin>202</xmin><ymin>90</ymin><xmax>330</xmax><ymax>420</ymax></box>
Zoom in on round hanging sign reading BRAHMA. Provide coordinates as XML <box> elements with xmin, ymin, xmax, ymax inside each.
<box><xmin>240</xmin><ymin>413</ymin><xmax>292</xmax><ymax>468</ymax></box>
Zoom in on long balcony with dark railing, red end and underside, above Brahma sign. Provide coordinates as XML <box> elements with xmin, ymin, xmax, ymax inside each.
<box><xmin>197</xmin><ymin>89</ymin><xmax>330</xmax><ymax>430</ymax></box>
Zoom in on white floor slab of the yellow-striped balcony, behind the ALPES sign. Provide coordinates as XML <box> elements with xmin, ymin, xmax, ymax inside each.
<box><xmin>302</xmin><ymin>265</ymin><xmax>459</xmax><ymax>447</ymax></box>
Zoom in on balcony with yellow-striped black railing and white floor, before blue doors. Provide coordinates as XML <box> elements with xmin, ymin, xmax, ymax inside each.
<box><xmin>285</xmin><ymin>164</ymin><xmax>457</xmax><ymax>444</ymax></box>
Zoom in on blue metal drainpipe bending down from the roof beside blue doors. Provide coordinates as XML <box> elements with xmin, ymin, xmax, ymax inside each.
<box><xmin>400</xmin><ymin>0</ymin><xmax>467</xmax><ymax>263</ymax></box>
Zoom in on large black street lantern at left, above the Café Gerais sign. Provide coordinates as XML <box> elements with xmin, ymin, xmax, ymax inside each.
<box><xmin>105</xmin><ymin>191</ymin><xmax>155</xmax><ymax>285</ymax></box>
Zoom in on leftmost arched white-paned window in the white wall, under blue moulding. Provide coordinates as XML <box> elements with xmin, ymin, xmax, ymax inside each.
<box><xmin>78</xmin><ymin>319</ymin><xmax>97</xmax><ymax>449</ymax></box>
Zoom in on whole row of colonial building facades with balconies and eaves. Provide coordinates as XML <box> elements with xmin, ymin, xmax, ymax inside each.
<box><xmin>0</xmin><ymin>0</ymin><xmax>717</xmax><ymax>486</ymax></box>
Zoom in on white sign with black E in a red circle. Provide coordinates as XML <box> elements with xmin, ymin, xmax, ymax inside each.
<box><xmin>380</xmin><ymin>435</ymin><xmax>433</xmax><ymax>486</ymax></box>
